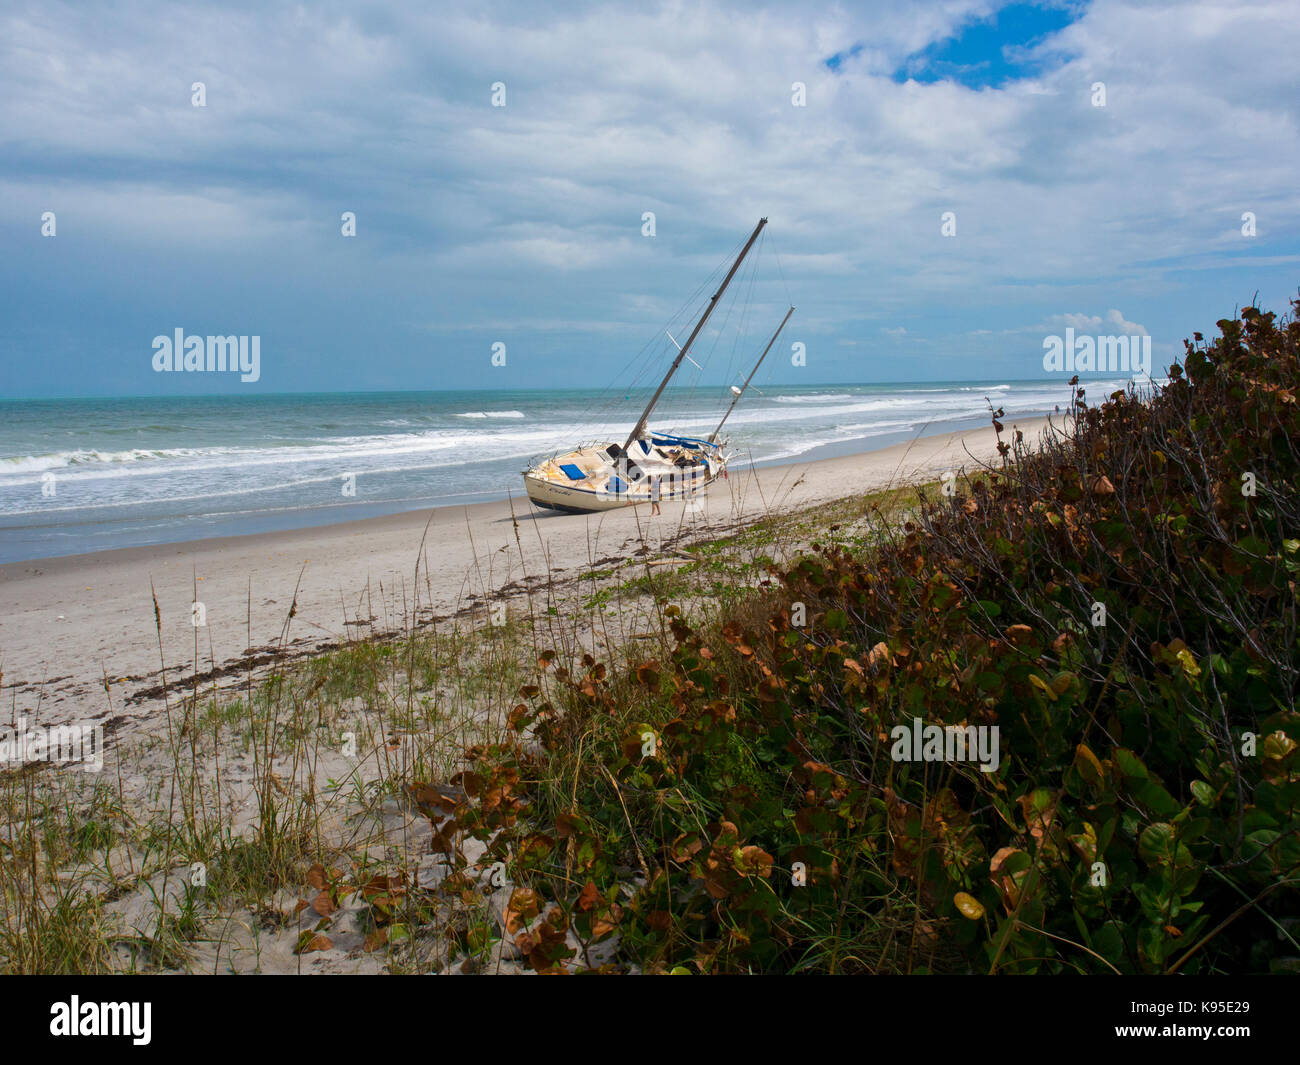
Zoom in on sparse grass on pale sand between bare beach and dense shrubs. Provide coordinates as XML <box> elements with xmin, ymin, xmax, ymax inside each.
<box><xmin>0</xmin><ymin>475</ymin><xmax>935</xmax><ymax>973</ymax></box>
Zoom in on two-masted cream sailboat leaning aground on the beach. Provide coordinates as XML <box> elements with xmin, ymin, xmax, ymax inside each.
<box><xmin>524</xmin><ymin>218</ymin><xmax>794</xmax><ymax>514</ymax></box>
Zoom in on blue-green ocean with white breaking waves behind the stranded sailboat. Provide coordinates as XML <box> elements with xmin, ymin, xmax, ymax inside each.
<box><xmin>0</xmin><ymin>381</ymin><xmax>1125</xmax><ymax>562</ymax></box>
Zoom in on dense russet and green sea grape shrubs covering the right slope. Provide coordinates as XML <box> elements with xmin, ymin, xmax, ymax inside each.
<box><xmin>439</xmin><ymin>295</ymin><xmax>1300</xmax><ymax>973</ymax></box>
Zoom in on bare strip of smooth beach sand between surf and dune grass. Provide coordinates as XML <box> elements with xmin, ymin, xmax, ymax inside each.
<box><xmin>0</xmin><ymin>419</ymin><xmax>1048</xmax><ymax>739</ymax></box>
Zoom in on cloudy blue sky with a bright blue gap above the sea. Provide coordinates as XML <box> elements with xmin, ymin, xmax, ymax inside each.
<box><xmin>0</xmin><ymin>0</ymin><xmax>1300</xmax><ymax>398</ymax></box>
